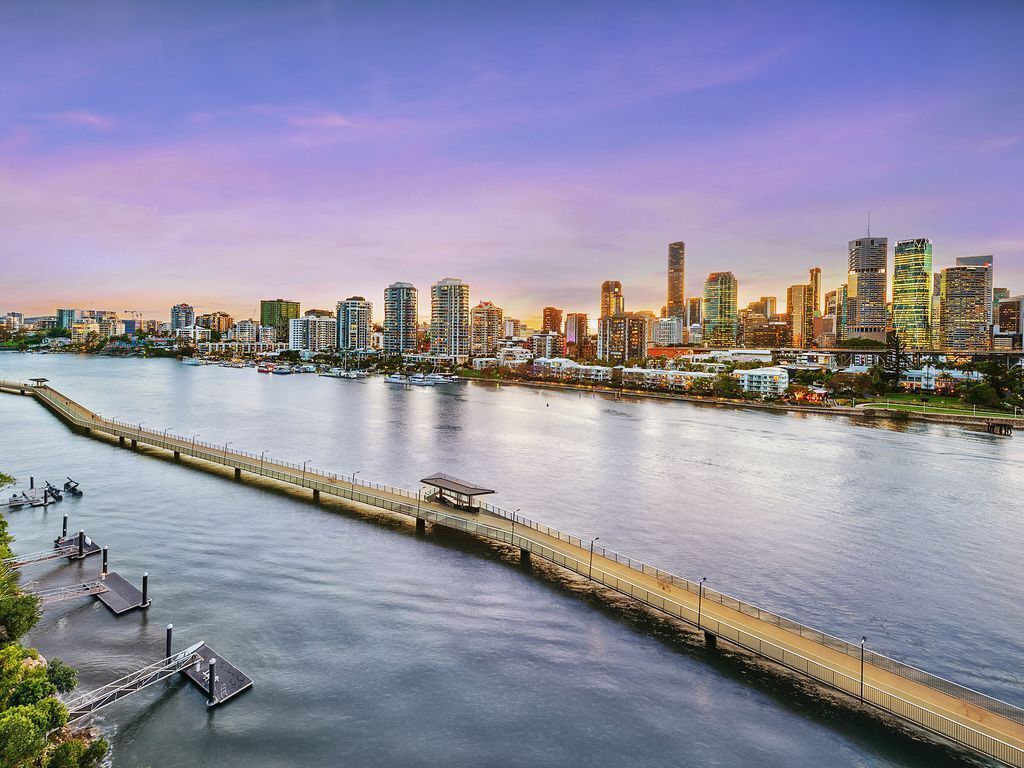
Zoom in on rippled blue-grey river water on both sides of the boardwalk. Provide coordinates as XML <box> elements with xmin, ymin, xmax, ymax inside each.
<box><xmin>0</xmin><ymin>354</ymin><xmax>1024</xmax><ymax>768</ymax></box>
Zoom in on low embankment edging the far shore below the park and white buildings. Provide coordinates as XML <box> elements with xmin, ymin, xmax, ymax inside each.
<box><xmin>467</xmin><ymin>377</ymin><xmax>1024</xmax><ymax>429</ymax></box>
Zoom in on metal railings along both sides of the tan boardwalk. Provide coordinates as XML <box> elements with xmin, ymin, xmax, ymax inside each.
<box><xmin>0</xmin><ymin>382</ymin><xmax>1024</xmax><ymax>766</ymax></box>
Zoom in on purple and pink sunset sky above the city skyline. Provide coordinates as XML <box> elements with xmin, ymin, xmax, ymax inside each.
<box><xmin>0</xmin><ymin>0</ymin><xmax>1024</xmax><ymax>321</ymax></box>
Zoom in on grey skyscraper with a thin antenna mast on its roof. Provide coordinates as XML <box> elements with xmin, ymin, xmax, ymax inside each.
<box><xmin>846</xmin><ymin>238</ymin><xmax>889</xmax><ymax>341</ymax></box>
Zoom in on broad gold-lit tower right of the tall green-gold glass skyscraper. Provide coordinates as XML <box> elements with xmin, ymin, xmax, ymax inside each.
<box><xmin>939</xmin><ymin>264</ymin><xmax>992</xmax><ymax>350</ymax></box>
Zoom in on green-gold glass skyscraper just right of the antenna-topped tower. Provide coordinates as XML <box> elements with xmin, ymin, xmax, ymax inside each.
<box><xmin>893</xmin><ymin>238</ymin><xmax>932</xmax><ymax>349</ymax></box>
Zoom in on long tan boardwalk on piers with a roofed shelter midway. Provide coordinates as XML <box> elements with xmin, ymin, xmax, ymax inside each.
<box><xmin>0</xmin><ymin>381</ymin><xmax>1024</xmax><ymax>768</ymax></box>
